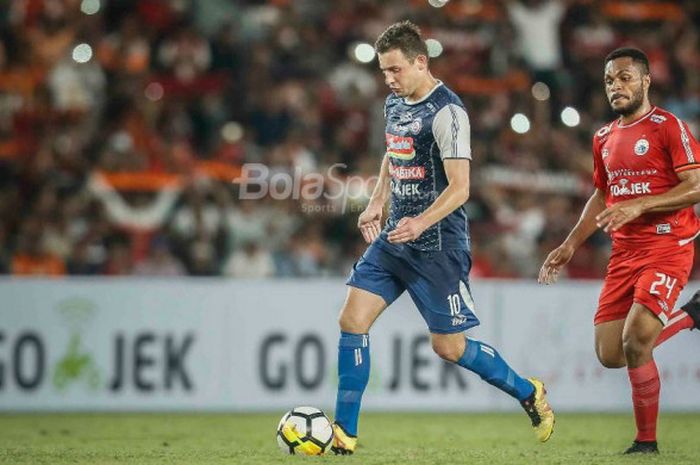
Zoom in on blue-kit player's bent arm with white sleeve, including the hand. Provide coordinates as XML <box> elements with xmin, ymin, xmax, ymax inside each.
<box><xmin>387</xmin><ymin>104</ymin><xmax>471</xmax><ymax>243</ymax></box>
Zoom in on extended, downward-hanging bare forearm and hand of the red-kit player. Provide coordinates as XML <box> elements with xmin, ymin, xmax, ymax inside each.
<box><xmin>537</xmin><ymin>187</ymin><xmax>605</xmax><ymax>284</ymax></box>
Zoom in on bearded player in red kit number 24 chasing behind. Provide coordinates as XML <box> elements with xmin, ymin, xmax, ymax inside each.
<box><xmin>539</xmin><ymin>48</ymin><xmax>700</xmax><ymax>453</ymax></box>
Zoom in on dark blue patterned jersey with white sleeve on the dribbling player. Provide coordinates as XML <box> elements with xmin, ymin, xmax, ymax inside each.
<box><xmin>383</xmin><ymin>82</ymin><xmax>471</xmax><ymax>251</ymax></box>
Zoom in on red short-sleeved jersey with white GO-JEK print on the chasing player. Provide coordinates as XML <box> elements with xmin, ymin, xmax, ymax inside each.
<box><xmin>593</xmin><ymin>107</ymin><xmax>700</xmax><ymax>248</ymax></box>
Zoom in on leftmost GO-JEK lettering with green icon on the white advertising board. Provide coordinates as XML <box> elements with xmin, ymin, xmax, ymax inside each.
<box><xmin>0</xmin><ymin>297</ymin><xmax>197</xmax><ymax>396</ymax></box>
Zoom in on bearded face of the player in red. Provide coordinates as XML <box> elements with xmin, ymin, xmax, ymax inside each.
<box><xmin>605</xmin><ymin>57</ymin><xmax>651</xmax><ymax>116</ymax></box>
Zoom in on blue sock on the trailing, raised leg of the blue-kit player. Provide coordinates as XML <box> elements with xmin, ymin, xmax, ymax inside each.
<box><xmin>457</xmin><ymin>339</ymin><xmax>535</xmax><ymax>401</ymax></box>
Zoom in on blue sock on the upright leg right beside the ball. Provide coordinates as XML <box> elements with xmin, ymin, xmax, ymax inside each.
<box><xmin>335</xmin><ymin>332</ymin><xmax>369</xmax><ymax>436</ymax></box>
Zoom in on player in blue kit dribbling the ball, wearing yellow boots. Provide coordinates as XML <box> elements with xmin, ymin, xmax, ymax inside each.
<box><xmin>332</xmin><ymin>21</ymin><xmax>554</xmax><ymax>454</ymax></box>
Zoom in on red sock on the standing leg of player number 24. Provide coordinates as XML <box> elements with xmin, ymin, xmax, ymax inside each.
<box><xmin>627</xmin><ymin>358</ymin><xmax>665</xmax><ymax>441</ymax></box>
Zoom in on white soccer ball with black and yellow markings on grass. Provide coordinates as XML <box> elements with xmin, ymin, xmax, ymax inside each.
<box><xmin>277</xmin><ymin>407</ymin><xmax>333</xmax><ymax>455</ymax></box>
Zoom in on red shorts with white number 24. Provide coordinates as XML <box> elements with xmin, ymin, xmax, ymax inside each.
<box><xmin>593</xmin><ymin>243</ymin><xmax>695</xmax><ymax>325</ymax></box>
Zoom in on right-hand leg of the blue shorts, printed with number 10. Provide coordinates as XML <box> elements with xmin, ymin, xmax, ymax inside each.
<box><xmin>406</xmin><ymin>250</ymin><xmax>479</xmax><ymax>334</ymax></box>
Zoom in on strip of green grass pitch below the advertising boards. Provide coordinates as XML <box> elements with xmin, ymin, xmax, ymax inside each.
<box><xmin>0</xmin><ymin>412</ymin><xmax>700</xmax><ymax>465</ymax></box>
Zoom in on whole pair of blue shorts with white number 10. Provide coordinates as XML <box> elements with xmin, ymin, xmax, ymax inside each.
<box><xmin>347</xmin><ymin>233</ymin><xmax>479</xmax><ymax>334</ymax></box>
